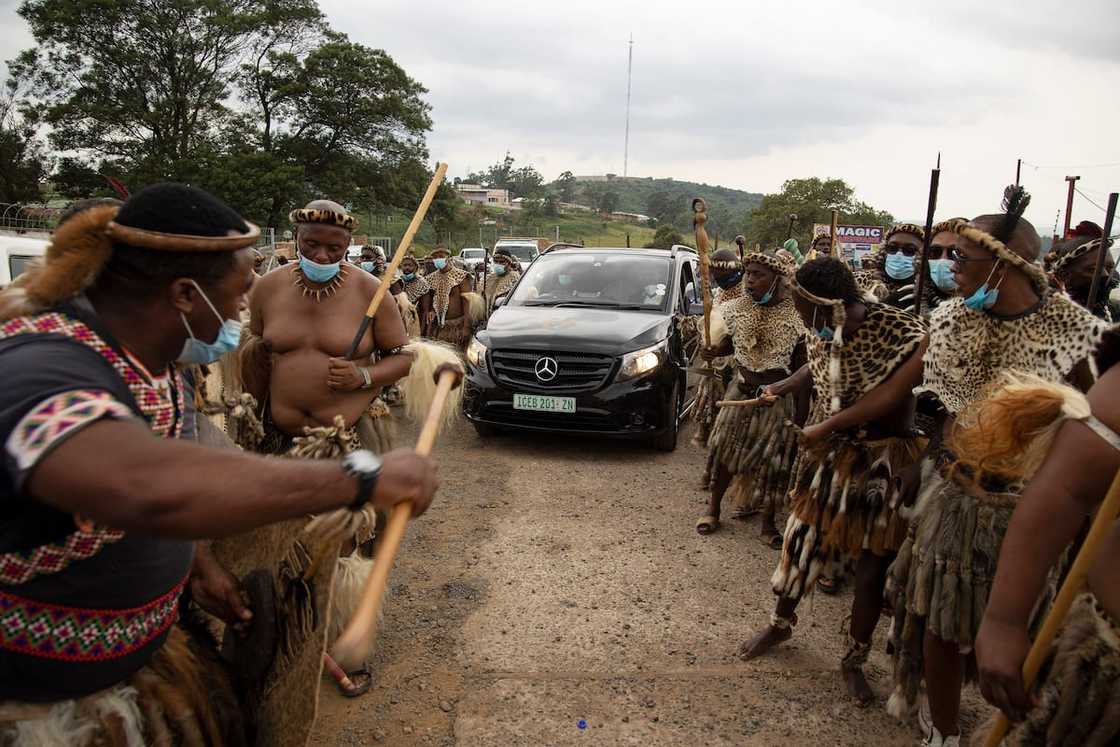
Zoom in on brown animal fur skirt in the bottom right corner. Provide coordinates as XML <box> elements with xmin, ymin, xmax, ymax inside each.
<box><xmin>1004</xmin><ymin>592</ymin><xmax>1120</xmax><ymax>747</ymax></box>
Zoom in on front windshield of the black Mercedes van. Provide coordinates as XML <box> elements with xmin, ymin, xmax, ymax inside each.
<box><xmin>510</xmin><ymin>251</ymin><xmax>671</xmax><ymax>311</ymax></box>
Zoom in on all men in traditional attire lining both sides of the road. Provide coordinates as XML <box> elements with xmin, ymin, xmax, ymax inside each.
<box><xmin>0</xmin><ymin>176</ymin><xmax>1120</xmax><ymax>746</ymax></box>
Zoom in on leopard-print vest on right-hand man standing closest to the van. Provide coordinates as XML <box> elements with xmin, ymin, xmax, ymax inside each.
<box><xmin>720</xmin><ymin>296</ymin><xmax>805</xmax><ymax>373</ymax></box>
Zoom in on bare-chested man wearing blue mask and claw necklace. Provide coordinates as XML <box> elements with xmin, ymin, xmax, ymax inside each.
<box><xmin>242</xmin><ymin>200</ymin><xmax>412</xmax><ymax>695</ymax></box>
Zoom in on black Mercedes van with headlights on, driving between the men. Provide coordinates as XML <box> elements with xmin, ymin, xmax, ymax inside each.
<box><xmin>464</xmin><ymin>246</ymin><xmax>703</xmax><ymax>450</ymax></box>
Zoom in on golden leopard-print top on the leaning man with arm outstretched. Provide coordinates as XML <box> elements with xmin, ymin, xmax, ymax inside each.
<box><xmin>805</xmin><ymin>304</ymin><xmax>925</xmax><ymax>423</ymax></box>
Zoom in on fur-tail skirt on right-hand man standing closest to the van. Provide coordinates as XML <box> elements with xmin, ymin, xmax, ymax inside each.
<box><xmin>707</xmin><ymin>380</ymin><xmax>797</xmax><ymax>515</ymax></box>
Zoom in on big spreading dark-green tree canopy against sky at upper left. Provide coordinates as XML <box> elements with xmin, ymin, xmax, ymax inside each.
<box><xmin>11</xmin><ymin>0</ymin><xmax>431</xmax><ymax>227</ymax></box>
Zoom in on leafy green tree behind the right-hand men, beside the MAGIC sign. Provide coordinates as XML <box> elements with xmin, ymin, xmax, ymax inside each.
<box><xmin>743</xmin><ymin>177</ymin><xmax>894</xmax><ymax>246</ymax></box>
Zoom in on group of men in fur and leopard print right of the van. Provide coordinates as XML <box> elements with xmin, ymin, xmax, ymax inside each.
<box><xmin>697</xmin><ymin>187</ymin><xmax>1120</xmax><ymax>746</ymax></box>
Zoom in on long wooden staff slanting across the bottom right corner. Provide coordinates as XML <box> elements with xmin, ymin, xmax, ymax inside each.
<box><xmin>984</xmin><ymin>468</ymin><xmax>1120</xmax><ymax>747</ymax></box>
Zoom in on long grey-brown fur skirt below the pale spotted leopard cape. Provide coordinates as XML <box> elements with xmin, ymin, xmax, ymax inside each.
<box><xmin>887</xmin><ymin>468</ymin><xmax>1018</xmax><ymax>718</ymax></box>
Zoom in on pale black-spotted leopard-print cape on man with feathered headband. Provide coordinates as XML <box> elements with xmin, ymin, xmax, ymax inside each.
<box><xmin>915</xmin><ymin>293</ymin><xmax>1109</xmax><ymax>415</ymax></box>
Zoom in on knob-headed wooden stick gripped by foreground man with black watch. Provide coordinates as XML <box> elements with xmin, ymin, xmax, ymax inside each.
<box><xmin>334</xmin><ymin>371</ymin><xmax>459</xmax><ymax>666</ymax></box>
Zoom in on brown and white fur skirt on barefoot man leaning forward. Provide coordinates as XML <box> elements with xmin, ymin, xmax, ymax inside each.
<box><xmin>771</xmin><ymin>435</ymin><xmax>925</xmax><ymax>599</ymax></box>
